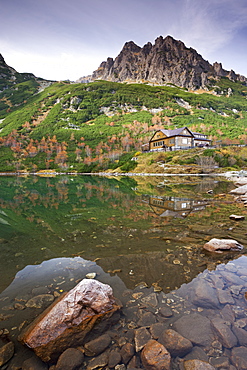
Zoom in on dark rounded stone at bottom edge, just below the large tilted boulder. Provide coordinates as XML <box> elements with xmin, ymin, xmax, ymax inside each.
<box><xmin>55</xmin><ymin>348</ymin><xmax>84</xmax><ymax>370</ymax></box>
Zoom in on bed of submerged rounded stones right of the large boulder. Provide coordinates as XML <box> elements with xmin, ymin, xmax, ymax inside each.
<box><xmin>0</xmin><ymin>256</ymin><xmax>247</xmax><ymax>370</ymax></box>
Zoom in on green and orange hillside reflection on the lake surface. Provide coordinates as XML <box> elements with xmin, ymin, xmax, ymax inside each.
<box><xmin>0</xmin><ymin>176</ymin><xmax>246</xmax><ymax>290</ymax></box>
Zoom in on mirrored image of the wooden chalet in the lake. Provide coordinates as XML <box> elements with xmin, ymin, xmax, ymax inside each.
<box><xmin>142</xmin><ymin>195</ymin><xmax>208</xmax><ymax>217</ymax></box>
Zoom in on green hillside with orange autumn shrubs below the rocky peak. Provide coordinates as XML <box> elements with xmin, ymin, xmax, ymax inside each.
<box><xmin>0</xmin><ymin>75</ymin><xmax>247</xmax><ymax>172</ymax></box>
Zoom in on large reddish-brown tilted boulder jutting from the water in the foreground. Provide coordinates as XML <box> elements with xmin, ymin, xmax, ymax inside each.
<box><xmin>20</xmin><ymin>279</ymin><xmax>120</xmax><ymax>362</ymax></box>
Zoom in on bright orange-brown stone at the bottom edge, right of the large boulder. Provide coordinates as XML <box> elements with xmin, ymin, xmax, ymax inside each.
<box><xmin>141</xmin><ymin>339</ymin><xmax>171</xmax><ymax>370</ymax></box>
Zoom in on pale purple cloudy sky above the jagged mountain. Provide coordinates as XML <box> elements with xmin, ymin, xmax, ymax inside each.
<box><xmin>0</xmin><ymin>0</ymin><xmax>247</xmax><ymax>81</ymax></box>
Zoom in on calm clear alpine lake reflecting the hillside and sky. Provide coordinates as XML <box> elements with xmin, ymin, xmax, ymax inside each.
<box><xmin>0</xmin><ymin>175</ymin><xmax>247</xmax><ymax>369</ymax></box>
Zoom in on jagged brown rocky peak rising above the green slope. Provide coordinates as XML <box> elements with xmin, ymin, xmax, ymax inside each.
<box><xmin>92</xmin><ymin>36</ymin><xmax>247</xmax><ymax>90</ymax></box>
